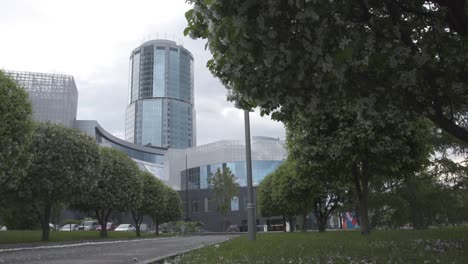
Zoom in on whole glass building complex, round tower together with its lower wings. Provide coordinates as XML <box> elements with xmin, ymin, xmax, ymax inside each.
<box><xmin>7</xmin><ymin>67</ymin><xmax>287</xmax><ymax>231</ymax></box>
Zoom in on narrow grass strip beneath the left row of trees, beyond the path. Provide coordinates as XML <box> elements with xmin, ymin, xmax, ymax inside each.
<box><xmin>0</xmin><ymin>230</ymin><xmax>172</xmax><ymax>244</ymax></box>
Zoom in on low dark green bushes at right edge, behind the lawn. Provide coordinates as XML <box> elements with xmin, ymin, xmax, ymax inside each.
<box><xmin>370</xmin><ymin>172</ymin><xmax>468</xmax><ymax>229</ymax></box>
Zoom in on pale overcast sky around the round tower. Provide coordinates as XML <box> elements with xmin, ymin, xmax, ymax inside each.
<box><xmin>0</xmin><ymin>0</ymin><xmax>285</xmax><ymax>145</ymax></box>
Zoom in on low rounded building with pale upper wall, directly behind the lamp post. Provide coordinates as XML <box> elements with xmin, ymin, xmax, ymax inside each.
<box><xmin>166</xmin><ymin>137</ymin><xmax>287</xmax><ymax>231</ymax></box>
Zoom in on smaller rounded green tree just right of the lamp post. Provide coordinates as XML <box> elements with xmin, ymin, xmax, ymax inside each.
<box><xmin>257</xmin><ymin>157</ymin><xmax>346</xmax><ymax>231</ymax></box>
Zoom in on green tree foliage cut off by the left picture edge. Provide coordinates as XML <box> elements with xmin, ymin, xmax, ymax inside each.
<box><xmin>0</xmin><ymin>70</ymin><xmax>33</xmax><ymax>192</ymax></box>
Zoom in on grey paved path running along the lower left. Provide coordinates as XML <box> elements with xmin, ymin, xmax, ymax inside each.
<box><xmin>0</xmin><ymin>235</ymin><xmax>234</xmax><ymax>264</ymax></box>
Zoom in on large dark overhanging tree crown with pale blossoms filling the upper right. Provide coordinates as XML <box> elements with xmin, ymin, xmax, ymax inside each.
<box><xmin>185</xmin><ymin>0</ymin><xmax>468</xmax><ymax>143</ymax></box>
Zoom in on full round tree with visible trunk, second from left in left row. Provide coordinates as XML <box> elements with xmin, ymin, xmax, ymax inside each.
<box><xmin>20</xmin><ymin>123</ymin><xmax>100</xmax><ymax>241</ymax></box>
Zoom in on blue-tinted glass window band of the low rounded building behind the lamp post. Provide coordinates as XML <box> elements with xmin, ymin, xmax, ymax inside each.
<box><xmin>180</xmin><ymin>160</ymin><xmax>283</xmax><ymax>190</ymax></box>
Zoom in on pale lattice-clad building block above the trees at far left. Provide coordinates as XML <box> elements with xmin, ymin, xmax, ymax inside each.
<box><xmin>5</xmin><ymin>71</ymin><xmax>78</xmax><ymax>127</ymax></box>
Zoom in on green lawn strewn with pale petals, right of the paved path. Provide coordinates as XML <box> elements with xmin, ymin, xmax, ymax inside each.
<box><xmin>165</xmin><ymin>227</ymin><xmax>468</xmax><ymax>264</ymax></box>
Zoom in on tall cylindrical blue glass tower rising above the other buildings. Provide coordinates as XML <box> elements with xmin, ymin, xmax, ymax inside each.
<box><xmin>125</xmin><ymin>40</ymin><xmax>196</xmax><ymax>149</ymax></box>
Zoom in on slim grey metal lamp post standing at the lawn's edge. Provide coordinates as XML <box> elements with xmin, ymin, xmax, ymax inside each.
<box><xmin>244</xmin><ymin>110</ymin><xmax>257</xmax><ymax>240</ymax></box>
